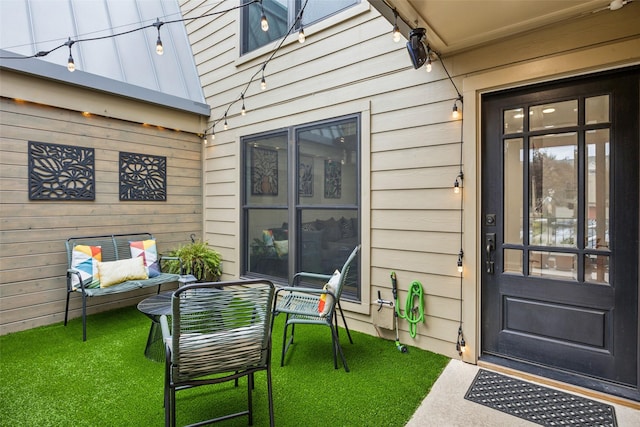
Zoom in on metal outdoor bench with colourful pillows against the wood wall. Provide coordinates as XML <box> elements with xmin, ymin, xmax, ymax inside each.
<box><xmin>64</xmin><ymin>233</ymin><xmax>182</xmax><ymax>341</ymax></box>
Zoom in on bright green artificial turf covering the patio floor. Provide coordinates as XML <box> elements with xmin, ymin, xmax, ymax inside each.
<box><xmin>0</xmin><ymin>307</ymin><xmax>449</xmax><ymax>427</ymax></box>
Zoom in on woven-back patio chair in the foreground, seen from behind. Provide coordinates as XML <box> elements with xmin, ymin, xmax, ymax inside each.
<box><xmin>160</xmin><ymin>280</ymin><xmax>274</xmax><ymax>426</ymax></box>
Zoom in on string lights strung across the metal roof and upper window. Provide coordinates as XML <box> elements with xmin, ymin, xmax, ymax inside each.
<box><xmin>0</xmin><ymin>0</ymin><xmax>309</xmax><ymax>144</ymax></box>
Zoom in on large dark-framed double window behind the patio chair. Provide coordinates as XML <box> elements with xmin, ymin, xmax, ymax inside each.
<box><xmin>243</xmin><ymin>115</ymin><xmax>360</xmax><ymax>299</ymax></box>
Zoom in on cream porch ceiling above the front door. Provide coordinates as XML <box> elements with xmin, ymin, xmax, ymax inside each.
<box><xmin>369</xmin><ymin>0</ymin><xmax>632</xmax><ymax>53</ymax></box>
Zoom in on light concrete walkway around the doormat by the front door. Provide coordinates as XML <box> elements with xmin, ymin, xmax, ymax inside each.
<box><xmin>407</xmin><ymin>360</ymin><xmax>640</xmax><ymax>427</ymax></box>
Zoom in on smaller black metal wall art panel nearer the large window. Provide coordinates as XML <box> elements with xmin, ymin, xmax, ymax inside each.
<box><xmin>119</xmin><ymin>152</ymin><xmax>167</xmax><ymax>201</ymax></box>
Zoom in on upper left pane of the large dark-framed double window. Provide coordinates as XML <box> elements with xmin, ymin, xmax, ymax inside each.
<box><xmin>245</xmin><ymin>134</ymin><xmax>288</xmax><ymax>206</ymax></box>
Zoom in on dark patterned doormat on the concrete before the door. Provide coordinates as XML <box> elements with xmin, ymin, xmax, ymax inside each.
<box><xmin>464</xmin><ymin>369</ymin><xmax>618</xmax><ymax>427</ymax></box>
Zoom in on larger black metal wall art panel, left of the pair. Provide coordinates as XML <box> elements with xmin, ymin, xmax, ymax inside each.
<box><xmin>28</xmin><ymin>141</ymin><xmax>96</xmax><ymax>200</ymax></box>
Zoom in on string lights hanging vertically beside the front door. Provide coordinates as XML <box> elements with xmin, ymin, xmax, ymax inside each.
<box><xmin>383</xmin><ymin>1</ymin><xmax>466</xmax><ymax>356</ymax></box>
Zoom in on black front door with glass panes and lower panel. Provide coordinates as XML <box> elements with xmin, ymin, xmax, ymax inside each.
<box><xmin>481</xmin><ymin>67</ymin><xmax>640</xmax><ymax>400</ymax></box>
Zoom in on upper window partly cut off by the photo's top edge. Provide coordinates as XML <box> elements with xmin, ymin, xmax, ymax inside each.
<box><xmin>242</xmin><ymin>0</ymin><xmax>360</xmax><ymax>55</ymax></box>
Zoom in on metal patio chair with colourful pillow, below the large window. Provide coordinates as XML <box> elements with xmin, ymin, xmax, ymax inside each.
<box><xmin>272</xmin><ymin>245</ymin><xmax>360</xmax><ymax>372</ymax></box>
